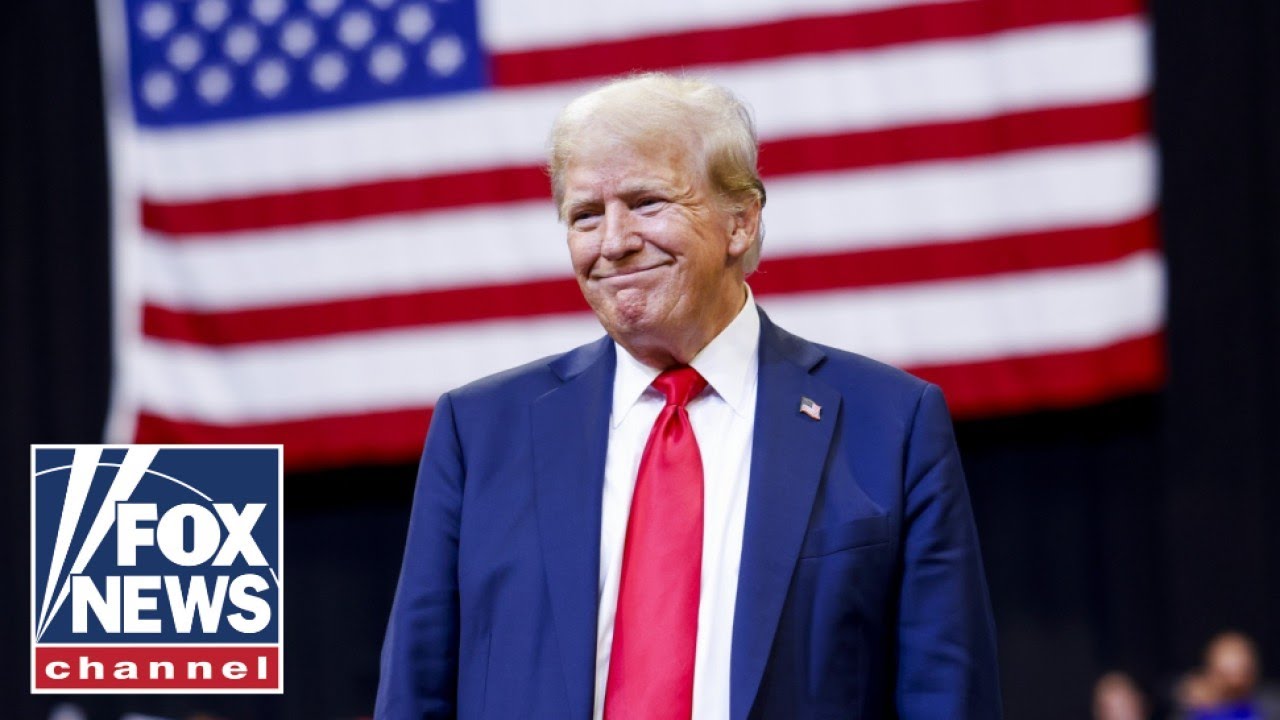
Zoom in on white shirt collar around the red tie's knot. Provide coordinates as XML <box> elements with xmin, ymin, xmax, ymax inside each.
<box><xmin>611</xmin><ymin>287</ymin><xmax>760</xmax><ymax>428</ymax></box>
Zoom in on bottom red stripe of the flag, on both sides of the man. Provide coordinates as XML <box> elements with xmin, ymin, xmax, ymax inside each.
<box><xmin>134</xmin><ymin>334</ymin><xmax>1165</xmax><ymax>470</ymax></box>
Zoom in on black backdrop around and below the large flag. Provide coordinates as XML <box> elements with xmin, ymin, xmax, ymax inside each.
<box><xmin>0</xmin><ymin>0</ymin><xmax>1280</xmax><ymax>720</ymax></box>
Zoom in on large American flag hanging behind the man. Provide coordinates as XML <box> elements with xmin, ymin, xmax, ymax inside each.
<box><xmin>100</xmin><ymin>0</ymin><xmax>1164</xmax><ymax>468</ymax></box>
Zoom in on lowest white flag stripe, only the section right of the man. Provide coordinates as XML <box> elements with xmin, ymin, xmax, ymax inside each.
<box><xmin>762</xmin><ymin>251</ymin><xmax>1165</xmax><ymax>366</ymax></box>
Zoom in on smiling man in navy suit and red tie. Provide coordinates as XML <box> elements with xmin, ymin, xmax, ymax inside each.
<box><xmin>376</xmin><ymin>74</ymin><xmax>1000</xmax><ymax>720</ymax></box>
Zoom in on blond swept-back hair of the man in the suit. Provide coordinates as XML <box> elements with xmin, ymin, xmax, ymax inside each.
<box><xmin>548</xmin><ymin>73</ymin><xmax>765</xmax><ymax>273</ymax></box>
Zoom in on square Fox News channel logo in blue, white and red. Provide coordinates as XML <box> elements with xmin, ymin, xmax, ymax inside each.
<box><xmin>31</xmin><ymin>445</ymin><xmax>284</xmax><ymax>693</ymax></box>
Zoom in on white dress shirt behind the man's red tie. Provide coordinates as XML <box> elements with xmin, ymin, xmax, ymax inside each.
<box><xmin>595</xmin><ymin>290</ymin><xmax>760</xmax><ymax>720</ymax></box>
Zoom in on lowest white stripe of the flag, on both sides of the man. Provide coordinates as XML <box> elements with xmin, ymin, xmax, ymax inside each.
<box><xmin>138</xmin><ymin>251</ymin><xmax>1164</xmax><ymax>423</ymax></box>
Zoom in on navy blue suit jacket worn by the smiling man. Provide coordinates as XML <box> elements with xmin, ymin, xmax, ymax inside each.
<box><xmin>376</xmin><ymin>313</ymin><xmax>1000</xmax><ymax>720</ymax></box>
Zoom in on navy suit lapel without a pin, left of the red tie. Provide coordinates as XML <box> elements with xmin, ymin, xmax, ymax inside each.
<box><xmin>532</xmin><ymin>337</ymin><xmax>616</xmax><ymax>720</ymax></box>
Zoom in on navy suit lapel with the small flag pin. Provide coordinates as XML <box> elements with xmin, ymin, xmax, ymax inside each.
<box><xmin>730</xmin><ymin>311</ymin><xmax>840</xmax><ymax>720</ymax></box>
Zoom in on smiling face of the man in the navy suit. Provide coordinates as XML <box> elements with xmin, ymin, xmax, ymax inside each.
<box><xmin>563</xmin><ymin>133</ymin><xmax>754</xmax><ymax>365</ymax></box>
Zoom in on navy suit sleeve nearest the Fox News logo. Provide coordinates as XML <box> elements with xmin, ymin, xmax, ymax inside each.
<box><xmin>374</xmin><ymin>395</ymin><xmax>465</xmax><ymax>720</ymax></box>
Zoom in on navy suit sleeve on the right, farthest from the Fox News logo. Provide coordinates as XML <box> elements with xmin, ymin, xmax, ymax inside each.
<box><xmin>896</xmin><ymin>384</ymin><xmax>1001</xmax><ymax>720</ymax></box>
